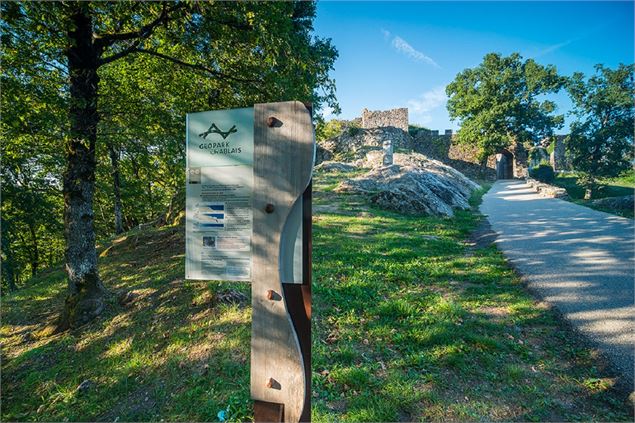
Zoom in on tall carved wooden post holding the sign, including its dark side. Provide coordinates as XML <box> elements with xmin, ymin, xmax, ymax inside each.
<box><xmin>251</xmin><ymin>101</ymin><xmax>315</xmax><ymax>422</ymax></box>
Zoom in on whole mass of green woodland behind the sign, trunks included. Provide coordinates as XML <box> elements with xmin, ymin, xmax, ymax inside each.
<box><xmin>0</xmin><ymin>1</ymin><xmax>337</xmax><ymax>327</ymax></box>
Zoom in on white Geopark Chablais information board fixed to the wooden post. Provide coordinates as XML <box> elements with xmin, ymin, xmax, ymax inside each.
<box><xmin>185</xmin><ymin>108</ymin><xmax>302</xmax><ymax>283</ymax></box>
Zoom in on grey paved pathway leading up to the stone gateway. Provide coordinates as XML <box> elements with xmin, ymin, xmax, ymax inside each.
<box><xmin>481</xmin><ymin>180</ymin><xmax>635</xmax><ymax>389</ymax></box>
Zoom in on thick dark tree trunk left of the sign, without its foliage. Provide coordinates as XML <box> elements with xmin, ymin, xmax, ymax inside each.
<box><xmin>58</xmin><ymin>6</ymin><xmax>106</xmax><ymax>330</ymax></box>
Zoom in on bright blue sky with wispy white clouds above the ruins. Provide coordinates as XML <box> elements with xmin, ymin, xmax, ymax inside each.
<box><xmin>314</xmin><ymin>1</ymin><xmax>634</xmax><ymax>133</ymax></box>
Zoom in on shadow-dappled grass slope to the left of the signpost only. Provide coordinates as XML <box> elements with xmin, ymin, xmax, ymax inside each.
<box><xmin>2</xmin><ymin>228</ymin><xmax>251</xmax><ymax>421</ymax></box>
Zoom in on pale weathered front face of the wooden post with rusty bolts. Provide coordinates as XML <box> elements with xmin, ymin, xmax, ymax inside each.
<box><xmin>251</xmin><ymin>101</ymin><xmax>314</xmax><ymax>422</ymax></box>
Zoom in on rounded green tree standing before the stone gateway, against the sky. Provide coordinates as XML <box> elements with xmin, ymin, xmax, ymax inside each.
<box><xmin>446</xmin><ymin>53</ymin><xmax>564</xmax><ymax>161</ymax></box>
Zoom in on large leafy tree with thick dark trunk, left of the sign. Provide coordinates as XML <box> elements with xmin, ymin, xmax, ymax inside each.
<box><xmin>1</xmin><ymin>1</ymin><xmax>337</xmax><ymax>328</ymax></box>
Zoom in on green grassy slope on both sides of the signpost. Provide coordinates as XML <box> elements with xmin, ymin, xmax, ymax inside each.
<box><xmin>1</xmin><ymin>170</ymin><xmax>632</xmax><ymax>421</ymax></box>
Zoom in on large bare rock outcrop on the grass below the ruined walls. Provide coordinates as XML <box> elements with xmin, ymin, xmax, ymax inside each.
<box><xmin>337</xmin><ymin>151</ymin><xmax>480</xmax><ymax>217</ymax></box>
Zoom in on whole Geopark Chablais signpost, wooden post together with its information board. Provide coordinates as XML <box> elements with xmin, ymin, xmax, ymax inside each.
<box><xmin>186</xmin><ymin>101</ymin><xmax>315</xmax><ymax>422</ymax></box>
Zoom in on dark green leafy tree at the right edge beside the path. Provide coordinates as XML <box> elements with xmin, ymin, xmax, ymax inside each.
<box><xmin>567</xmin><ymin>64</ymin><xmax>635</xmax><ymax>198</ymax></box>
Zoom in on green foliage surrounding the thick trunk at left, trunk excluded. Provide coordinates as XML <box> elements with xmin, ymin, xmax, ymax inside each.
<box><xmin>0</xmin><ymin>2</ymin><xmax>338</xmax><ymax>287</ymax></box>
